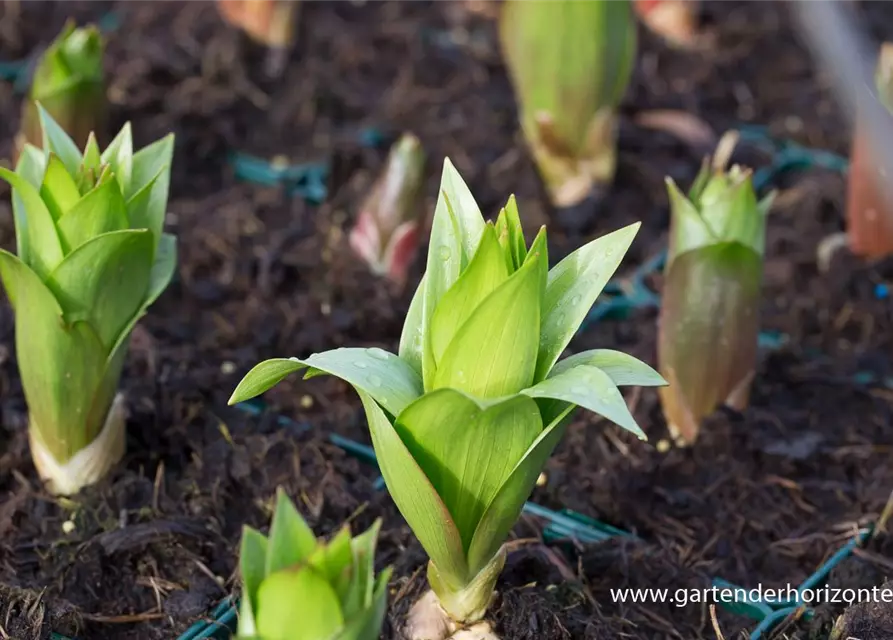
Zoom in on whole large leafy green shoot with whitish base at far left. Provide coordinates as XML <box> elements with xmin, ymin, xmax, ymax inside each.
<box><xmin>0</xmin><ymin>106</ymin><xmax>176</xmax><ymax>494</ymax></box>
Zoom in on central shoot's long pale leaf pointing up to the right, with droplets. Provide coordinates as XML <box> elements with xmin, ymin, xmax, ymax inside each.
<box><xmin>535</xmin><ymin>222</ymin><xmax>641</xmax><ymax>380</ymax></box>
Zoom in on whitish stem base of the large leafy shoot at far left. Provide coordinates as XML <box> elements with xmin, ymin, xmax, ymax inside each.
<box><xmin>28</xmin><ymin>393</ymin><xmax>127</xmax><ymax>496</ymax></box>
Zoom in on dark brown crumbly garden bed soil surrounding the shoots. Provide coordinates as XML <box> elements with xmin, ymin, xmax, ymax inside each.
<box><xmin>0</xmin><ymin>0</ymin><xmax>893</xmax><ymax>640</ymax></box>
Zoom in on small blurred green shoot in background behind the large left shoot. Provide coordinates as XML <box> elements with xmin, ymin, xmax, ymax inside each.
<box><xmin>19</xmin><ymin>22</ymin><xmax>106</xmax><ymax>154</ymax></box>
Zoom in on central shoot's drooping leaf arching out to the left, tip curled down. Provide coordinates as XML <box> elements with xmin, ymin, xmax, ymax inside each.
<box><xmin>229</xmin><ymin>348</ymin><xmax>422</xmax><ymax>415</ymax></box>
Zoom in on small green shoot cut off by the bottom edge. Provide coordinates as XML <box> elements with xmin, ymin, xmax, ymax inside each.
<box><xmin>238</xmin><ymin>489</ymin><xmax>391</xmax><ymax>640</ymax></box>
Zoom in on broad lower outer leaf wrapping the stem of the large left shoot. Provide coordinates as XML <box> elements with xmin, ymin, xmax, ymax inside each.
<box><xmin>0</xmin><ymin>251</ymin><xmax>109</xmax><ymax>462</ymax></box>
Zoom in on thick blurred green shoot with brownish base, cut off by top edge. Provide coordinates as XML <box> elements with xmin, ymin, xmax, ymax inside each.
<box><xmin>499</xmin><ymin>0</ymin><xmax>636</xmax><ymax>207</ymax></box>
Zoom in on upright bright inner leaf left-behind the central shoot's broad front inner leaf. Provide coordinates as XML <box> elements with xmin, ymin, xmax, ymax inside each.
<box><xmin>428</xmin><ymin>225</ymin><xmax>509</xmax><ymax>365</ymax></box>
